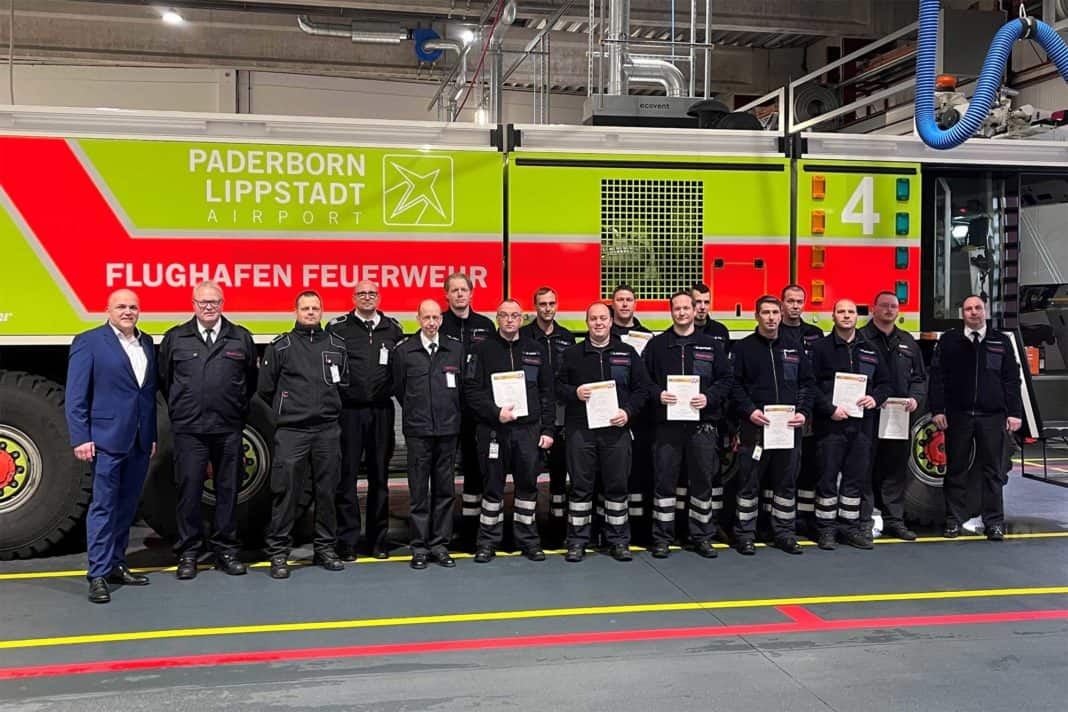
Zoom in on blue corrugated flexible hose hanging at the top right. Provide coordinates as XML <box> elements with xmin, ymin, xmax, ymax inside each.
<box><xmin>915</xmin><ymin>0</ymin><xmax>1068</xmax><ymax>151</ymax></box>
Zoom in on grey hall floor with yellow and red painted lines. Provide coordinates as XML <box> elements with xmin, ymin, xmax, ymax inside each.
<box><xmin>0</xmin><ymin>475</ymin><xmax>1068</xmax><ymax>712</ymax></box>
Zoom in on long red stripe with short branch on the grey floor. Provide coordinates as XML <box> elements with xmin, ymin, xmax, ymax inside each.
<box><xmin>0</xmin><ymin>606</ymin><xmax>1068</xmax><ymax>680</ymax></box>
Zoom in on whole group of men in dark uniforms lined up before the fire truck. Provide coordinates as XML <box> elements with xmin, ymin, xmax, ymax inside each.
<box><xmin>68</xmin><ymin>273</ymin><xmax>1022</xmax><ymax>602</ymax></box>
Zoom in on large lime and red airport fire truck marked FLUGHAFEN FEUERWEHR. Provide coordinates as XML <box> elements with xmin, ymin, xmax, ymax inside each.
<box><xmin>0</xmin><ymin>107</ymin><xmax>1046</xmax><ymax>558</ymax></box>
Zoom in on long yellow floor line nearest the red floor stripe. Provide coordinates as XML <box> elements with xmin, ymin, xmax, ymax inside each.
<box><xmin>0</xmin><ymin>586</ymin><xmax>1068</xmax><ymax>650</ymax></box>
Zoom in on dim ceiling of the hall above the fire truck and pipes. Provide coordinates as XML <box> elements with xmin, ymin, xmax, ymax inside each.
<box><xmin>0</xmin><ymin>0</ymin><xmax>916</xmax><ymax>94</ymax></box>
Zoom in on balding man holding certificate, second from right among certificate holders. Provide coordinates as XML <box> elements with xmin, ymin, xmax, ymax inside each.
<box><xmin>812</xmin><ymin>299</ymin><xmax>891</xmax><ymax>550</ymax></box>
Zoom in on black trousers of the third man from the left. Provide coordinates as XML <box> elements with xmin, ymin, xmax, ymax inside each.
<box><xmin>265</xmin><ymin>422</ymin><xmax>341</xmax><ymax>558</ymax></box>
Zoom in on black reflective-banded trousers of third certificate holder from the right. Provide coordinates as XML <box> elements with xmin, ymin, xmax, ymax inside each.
<box><xmin>734</xmin><ymin>426</ymin><xmax>801</xmax><ymax>541</ymax></box>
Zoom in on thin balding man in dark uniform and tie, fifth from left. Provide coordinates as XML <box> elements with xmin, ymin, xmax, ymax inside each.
<box><xmin>390</xmin><ymin>299</ymin><xmax>465</xmax><ymax>570</ymax></box>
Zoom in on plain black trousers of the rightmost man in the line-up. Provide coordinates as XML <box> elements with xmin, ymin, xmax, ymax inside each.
<box><xmin>942</xmin><ymin>413</ymin><xmax>1007</xmax><ymax>527</ymax></box>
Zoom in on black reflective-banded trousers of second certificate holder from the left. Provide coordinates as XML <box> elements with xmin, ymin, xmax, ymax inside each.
<box><xmin>566</xmin><ymin>428</ymin><xmax>631</xmax><ymax>548</ymax></box>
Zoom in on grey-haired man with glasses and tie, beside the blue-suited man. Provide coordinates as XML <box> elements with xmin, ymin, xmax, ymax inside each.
<box><xmin>158</xmin><ymin>282</ymin><xmax>256</xmax><ymax>581</ymax></box>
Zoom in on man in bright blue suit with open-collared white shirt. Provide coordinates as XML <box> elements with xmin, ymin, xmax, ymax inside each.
<box><xmin>65</xmin><ymin>289</ymin><xmax>156</xmax><ymax>603</ymax></box>
